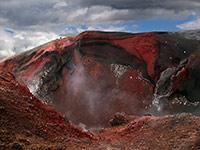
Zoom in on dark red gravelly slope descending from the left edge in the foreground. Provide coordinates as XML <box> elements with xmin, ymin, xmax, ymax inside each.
<box><xmin>0</xmin><ymin>70</ymin><xmax>94</xmax><ymax>150</ymax></box>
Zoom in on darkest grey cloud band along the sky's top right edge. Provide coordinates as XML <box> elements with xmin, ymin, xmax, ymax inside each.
<box><xmin>80</xmin><ymin>0</ymin><xmax>200</xmax><ymax>11</ymax></box>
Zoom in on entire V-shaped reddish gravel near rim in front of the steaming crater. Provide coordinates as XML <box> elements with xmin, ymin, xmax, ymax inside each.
<box><xmin>0</xmin><ymin>71</ymin><xmax>200</xmax><ymax>150</ymax></box>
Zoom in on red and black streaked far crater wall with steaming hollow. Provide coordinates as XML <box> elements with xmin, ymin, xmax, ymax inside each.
<box><xmin>1</xmin><ymin>31</ymin><xmax>200</xmax><ymax>130</ymax></box>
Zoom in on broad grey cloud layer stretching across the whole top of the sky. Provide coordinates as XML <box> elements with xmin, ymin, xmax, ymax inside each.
<box><xmin>0</xmin><ymin>0</ymin><xmax>200</xmax><ymax>28</ymax></box>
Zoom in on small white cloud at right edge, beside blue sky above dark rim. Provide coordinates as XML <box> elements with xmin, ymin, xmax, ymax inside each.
<box><xmin>177</xmin><ymin>17</ymin><xmax>200</xmax><ymax>30</ymax></box>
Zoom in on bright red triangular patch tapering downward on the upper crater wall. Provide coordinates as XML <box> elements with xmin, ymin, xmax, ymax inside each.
<box><xmin>112</xmin><ymin>32</ymin><xmax>159</xmax><ymax>77</ymax></box>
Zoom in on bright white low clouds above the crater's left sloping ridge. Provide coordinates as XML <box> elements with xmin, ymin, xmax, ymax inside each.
<box><xmin>0</xmin><ymin>25</ymin><xmax>130</xmax><ymax>58</ymax></box>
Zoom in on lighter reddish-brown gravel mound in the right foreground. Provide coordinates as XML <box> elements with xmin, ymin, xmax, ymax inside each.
<box><xmin>96</xmin><ymin>114</ymin><xmax>200</xmax><ymax>150</ymax></box>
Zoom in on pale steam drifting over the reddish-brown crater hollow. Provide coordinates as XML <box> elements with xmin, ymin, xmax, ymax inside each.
<box><xmin>53</xmin><ymin>64</ymin><xmax>136</xmax><ymax>131</ymax></box>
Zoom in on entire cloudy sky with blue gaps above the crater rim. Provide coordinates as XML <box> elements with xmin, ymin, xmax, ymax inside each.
<box><xmin>0</xmin><ymin>0</ymin><xmax>200</xmax><ymax>58</ymax></box>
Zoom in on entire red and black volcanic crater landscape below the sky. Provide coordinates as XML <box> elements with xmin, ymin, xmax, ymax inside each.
<box><xmin>0</xmin><ymin>31</ymin><xmax>200</xmax><ymax>150</ymax></box>
